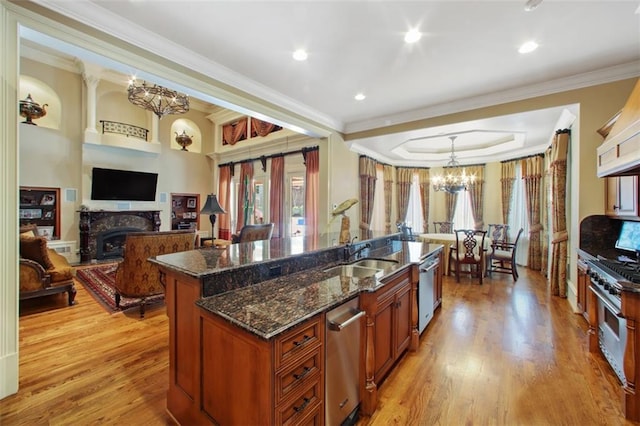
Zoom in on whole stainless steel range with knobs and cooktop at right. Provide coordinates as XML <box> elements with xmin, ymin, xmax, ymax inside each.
<box><xmin>586</xmin><ymin>256</ymin><xmax>640</xmax><ymax>384</ymax></box>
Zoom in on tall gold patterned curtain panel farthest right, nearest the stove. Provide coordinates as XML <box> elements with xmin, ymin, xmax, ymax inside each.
<box><xmin>549</xmin><ymin>129</ymin><xmax>570</xmax><ymax>297</ymax></box>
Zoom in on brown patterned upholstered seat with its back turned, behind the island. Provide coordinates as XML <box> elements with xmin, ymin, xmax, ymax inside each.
<box><xmin>115</xmin><ymin>230</ymin><xmax>196</xmax><ymax>318</ymax></box>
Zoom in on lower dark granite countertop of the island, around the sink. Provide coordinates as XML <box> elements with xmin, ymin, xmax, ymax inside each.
<box><xmin>196</xmin><ymin>242</ymin><xmax>443</xmax><ymax>340</ymax></box>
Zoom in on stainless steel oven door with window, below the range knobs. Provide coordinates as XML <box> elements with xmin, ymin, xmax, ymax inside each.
<box><xmin>589</xmin><ymin>284</ymin><xmax>627</xmax><ymax>384</ymax></box>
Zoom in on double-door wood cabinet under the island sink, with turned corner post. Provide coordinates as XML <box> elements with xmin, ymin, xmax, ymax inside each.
<box><xmin>360</xmin><ymin>265</ymin><xmax>417</xmax><ymax>415</ymax></box>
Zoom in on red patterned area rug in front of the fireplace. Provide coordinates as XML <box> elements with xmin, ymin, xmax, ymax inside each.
<box><xmin>76</xmin><ymin>264</ymin><xmax>164</xmax><ymax>313</ymax></box>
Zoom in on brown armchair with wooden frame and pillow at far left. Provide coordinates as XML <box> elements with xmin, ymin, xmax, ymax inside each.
<box><xmin>19</xmin><ymin>228</ymin><xmax>76</xmax><ymax>305</ymax></box>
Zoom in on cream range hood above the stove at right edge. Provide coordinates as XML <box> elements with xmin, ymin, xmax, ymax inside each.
<box><xmin>597</xmin><ymin>79</ymin><xmax>640</xmax><ymax>177</ymax></box>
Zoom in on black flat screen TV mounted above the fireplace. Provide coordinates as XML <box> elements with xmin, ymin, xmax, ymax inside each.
<box><xmin>91</xmin><ymin>167</ymin><xmax>158</xmax><ymax>201</ymax></box>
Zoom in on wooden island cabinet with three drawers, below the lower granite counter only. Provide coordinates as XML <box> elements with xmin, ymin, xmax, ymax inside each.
<box><xmin>200</xmin><ymin>310</ymin><xmax>324</xmax><ymax>425</ymax></box>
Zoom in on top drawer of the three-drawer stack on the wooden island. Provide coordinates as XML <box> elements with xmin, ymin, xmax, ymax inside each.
<box><xmin>275</xmin><ymin>317</ymin><xmax>322</xmax><ymax>371</ymax></box>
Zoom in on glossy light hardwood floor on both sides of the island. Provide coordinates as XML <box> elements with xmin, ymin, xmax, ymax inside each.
<box><xmin>0</xmin><ymin>268</ymin><xmax>633</xmax><ymax>426</ymax></box>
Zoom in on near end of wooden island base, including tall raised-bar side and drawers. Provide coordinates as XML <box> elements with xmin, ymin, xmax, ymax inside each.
<box><xmin>160</xmin><ymin>267</ymin><xmax>325</xmax><ymax>425</ymax></box>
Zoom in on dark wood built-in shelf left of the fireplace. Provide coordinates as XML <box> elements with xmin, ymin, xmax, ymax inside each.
<box><xmin>20</xmin><ymin>186</ymin><xmax>60</xmax><ymax>239</ymax></box>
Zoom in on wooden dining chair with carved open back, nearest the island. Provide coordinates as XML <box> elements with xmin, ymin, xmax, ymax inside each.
<box><xmin>449</xmin><ymin>229</ymin><xmax>487</xmax><ymax>284</ymax></box>
